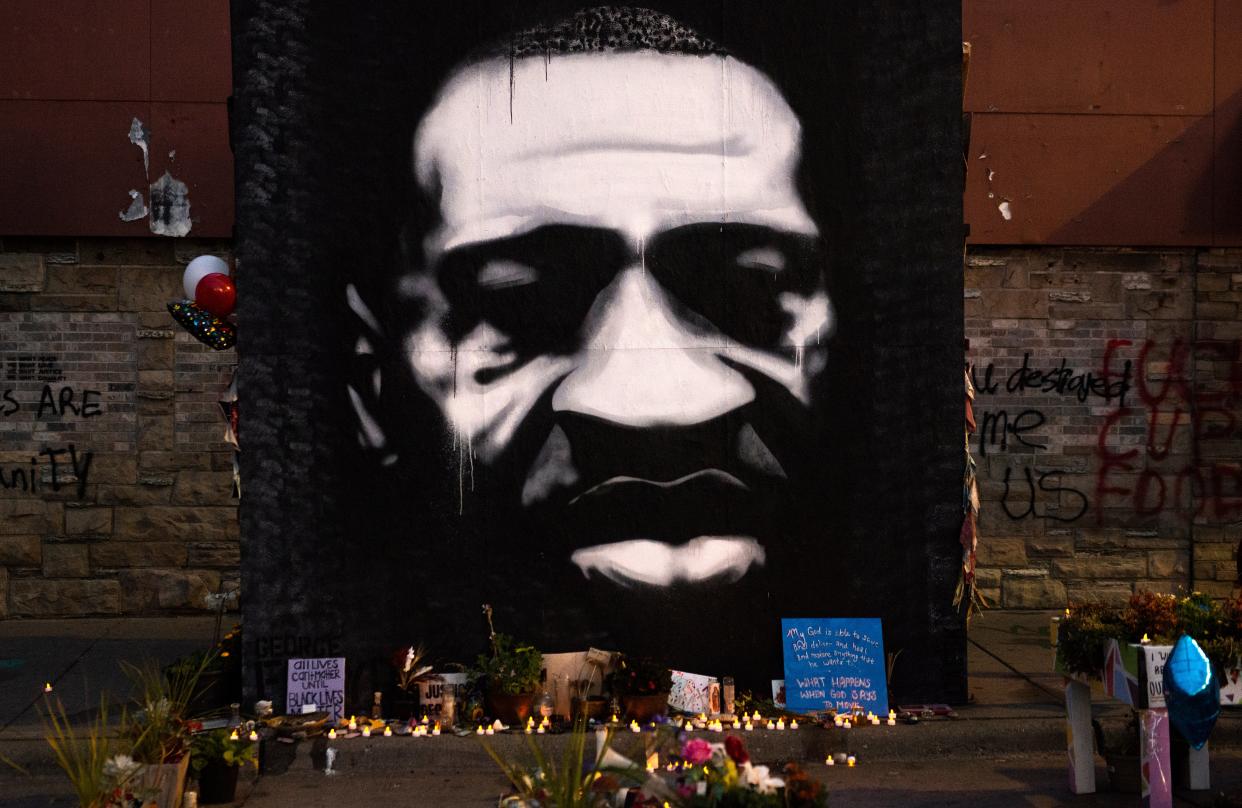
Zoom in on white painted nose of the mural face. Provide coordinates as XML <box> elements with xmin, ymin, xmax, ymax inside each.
<box><xmin>551</xmin><ymin>267</ymin><xmax>755</xmax><ymax>427</ymax></box>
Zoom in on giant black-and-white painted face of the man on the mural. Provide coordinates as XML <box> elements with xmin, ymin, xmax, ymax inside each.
<box><xmin>350</xmin><ymin>51</ymin><xmax>832</xmax><ymax>587</ymax></box>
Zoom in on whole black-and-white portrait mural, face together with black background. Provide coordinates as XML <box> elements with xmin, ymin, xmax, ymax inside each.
<box><xmin>234</xmin><ymin>0</ymin><xmax>961</xmax><ymax>691</ymax></box>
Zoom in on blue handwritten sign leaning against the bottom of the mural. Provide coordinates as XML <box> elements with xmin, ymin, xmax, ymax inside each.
<box><xmin>780</xmin><ymin>617</ymin><xmax>888</xmax><ymax>716</ymax></box>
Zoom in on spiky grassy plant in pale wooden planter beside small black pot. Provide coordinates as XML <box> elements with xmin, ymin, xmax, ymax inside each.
<box><xmin>120</xmin><ymin>657</ymin><xmax>211</xmax><ymax>808</ymax></box>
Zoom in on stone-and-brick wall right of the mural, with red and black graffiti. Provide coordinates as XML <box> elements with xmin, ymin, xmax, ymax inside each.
<box><xmin>965</xmin><ymin>247</ymin><xmax>1242</xmax><ymax>608</ymax></box>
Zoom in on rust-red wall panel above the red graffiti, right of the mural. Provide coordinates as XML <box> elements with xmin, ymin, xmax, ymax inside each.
<box><xmin>963</xmin><ymin>0</ymin><xmax>1242</xmax><ymax>246</ymax></box>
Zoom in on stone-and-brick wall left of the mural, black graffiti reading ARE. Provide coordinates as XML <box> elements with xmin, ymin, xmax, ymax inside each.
<box><xmin>0</xmin><ymin>238</ymin><xmax>240</xmax><ymax>617</ymax></box>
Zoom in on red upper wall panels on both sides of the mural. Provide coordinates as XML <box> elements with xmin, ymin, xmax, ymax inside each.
<box><xmin>0</xmin><ymin>0</ymin><xmax>1242</xmax><ymax>246</ymax></box>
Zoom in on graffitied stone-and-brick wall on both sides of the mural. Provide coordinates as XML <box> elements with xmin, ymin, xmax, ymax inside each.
<box><xmin>0</xmin><ymin>238</ymin><xmax>1242</xmax><ymax>617</ymax></box>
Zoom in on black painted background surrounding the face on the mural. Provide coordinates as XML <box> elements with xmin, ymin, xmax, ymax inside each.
<box><xmin>231</xmin><ymin>0</ymin><xmax>965</xmax><ymax>709</ymax></box>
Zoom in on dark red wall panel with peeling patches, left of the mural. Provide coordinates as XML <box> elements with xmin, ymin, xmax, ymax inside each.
<box><xmin>0</xmin><ymin>0</ymin><xmax>233</xmax><ymax>237</ymax></box>
